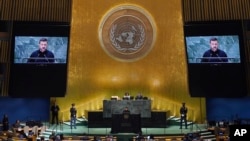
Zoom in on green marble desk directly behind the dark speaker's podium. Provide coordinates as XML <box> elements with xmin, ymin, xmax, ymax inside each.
<box><xmin>103</xmin><ymin>100</ymin><xmax>151</xmax><ymax>118</ymax></box>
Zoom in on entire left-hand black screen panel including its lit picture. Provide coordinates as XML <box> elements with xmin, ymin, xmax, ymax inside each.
<box><xmin>9</xmin><ymin>21</ymin><xmax>70</xmax><ymax>97</ymax></box>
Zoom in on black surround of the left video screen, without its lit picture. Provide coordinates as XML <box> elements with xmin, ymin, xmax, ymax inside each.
<box><xmin>8</xmin><ymin>21</ymin><xmax>71</xmax><ymax>97</ymax></box>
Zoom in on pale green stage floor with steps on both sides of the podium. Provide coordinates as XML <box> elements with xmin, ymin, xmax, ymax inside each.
<box><xmin>38</xmin><ymin>123</ymin><xmax>216</xmax><ymax>141</ymax></box>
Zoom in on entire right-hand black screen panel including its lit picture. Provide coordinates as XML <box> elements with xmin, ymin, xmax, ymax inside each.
<box><xmin>184</xmin><ymin>20</ymin><xmax>247</xmax><ymax>98</ymax></box>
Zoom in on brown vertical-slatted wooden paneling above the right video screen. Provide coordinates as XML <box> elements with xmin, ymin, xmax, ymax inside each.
<box><xmin>182</xmin><ymin>0</ymin><xmax>250</xmax><ymax>22</ymax></box>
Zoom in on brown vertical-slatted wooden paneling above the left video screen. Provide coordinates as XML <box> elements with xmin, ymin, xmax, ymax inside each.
<box><xmin>0</xmin><ymin>0</ymin><xmax>72</xmax><ymax>22</ymax></box>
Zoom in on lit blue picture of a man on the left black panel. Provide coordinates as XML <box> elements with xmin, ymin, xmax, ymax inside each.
<box><xmin>14</xmin><ymin>36</ymin><xmax>68</xmax><ymax>64</ymax></box>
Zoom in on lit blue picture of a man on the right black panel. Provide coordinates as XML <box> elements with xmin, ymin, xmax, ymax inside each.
<box><xmin>185</xmin><ymin>35</ymin><xmax>241</xmax><ymax>63</ymax></box>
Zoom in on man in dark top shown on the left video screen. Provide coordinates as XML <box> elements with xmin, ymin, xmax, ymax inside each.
<box><xmin>28</xmin><ymin>38</ymin><xmax>55</xmax><ymax>63</ymax></box>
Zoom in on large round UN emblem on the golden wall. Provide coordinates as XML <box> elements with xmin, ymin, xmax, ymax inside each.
<box><xmin>99</xmin><ymin>5</ymin><xmax>156</xmax><ymax>62</ymax></box>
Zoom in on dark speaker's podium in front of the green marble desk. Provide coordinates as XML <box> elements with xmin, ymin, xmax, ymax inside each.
<box><xmin>111</xmin><ymin>113</ymin><xmax>141</xmax><ymax>133</ymax></box>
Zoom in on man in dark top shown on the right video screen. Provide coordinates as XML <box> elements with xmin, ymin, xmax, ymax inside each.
<box><xmin>201</xmin><ymin>37</ymin><xmax>228</xmax><ymax>63</ymax></box>
